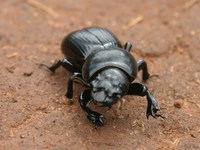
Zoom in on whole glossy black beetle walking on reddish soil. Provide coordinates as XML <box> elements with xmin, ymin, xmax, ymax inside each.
<box><xmin>45</xmin><ymin>27</ymin><xmax>159</xmax><ymax>125</ymax></box>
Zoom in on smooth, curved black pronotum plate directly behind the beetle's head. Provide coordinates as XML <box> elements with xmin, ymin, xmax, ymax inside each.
<box><xmin>82</xmin><ymin>48</ymin><xmax>137</xmax><ymax>81</ymax></box>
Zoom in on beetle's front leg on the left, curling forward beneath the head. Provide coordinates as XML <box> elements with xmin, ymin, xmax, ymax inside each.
<box><xmin>79</xmin><ymin>89</ymin><xmax>104</xmax><ymax>126</ymax></box>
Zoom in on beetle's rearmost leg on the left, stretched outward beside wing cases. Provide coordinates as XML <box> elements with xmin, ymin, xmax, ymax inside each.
<box><xmin>41</xmin><ymin>58</ymin><xmax>79</xmax><ymax>73</ymax></box>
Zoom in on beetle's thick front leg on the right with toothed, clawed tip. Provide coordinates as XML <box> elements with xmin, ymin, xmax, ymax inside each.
<box><xmin>127</xmin><ymin>83</ymin><xmax>159</xmax><ymax>118</ymax></box>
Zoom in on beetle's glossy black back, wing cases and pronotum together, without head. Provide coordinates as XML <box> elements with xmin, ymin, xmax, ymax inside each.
<box><xmin>61</xmin><ymin>28</ymin><xmax>137</xmax><ymax>82</ymax></box>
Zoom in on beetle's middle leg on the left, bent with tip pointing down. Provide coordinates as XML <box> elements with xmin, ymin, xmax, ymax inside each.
<box><xmin>65</xmin><ymin>73</ymin><xmax>90</xmax><ymax>99</ymax></box>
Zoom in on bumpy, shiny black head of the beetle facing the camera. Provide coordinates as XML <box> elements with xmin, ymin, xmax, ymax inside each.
<box><xmin>91</xmin><ymin>68</ymin><xmax>130</xmax><ymax>106</ymax></box>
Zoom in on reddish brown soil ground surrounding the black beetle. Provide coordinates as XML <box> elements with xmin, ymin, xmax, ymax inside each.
<box><xmin>0</xmin><ymin>0</ymin><xmax>200</xmax><ymax>150</ymax></box>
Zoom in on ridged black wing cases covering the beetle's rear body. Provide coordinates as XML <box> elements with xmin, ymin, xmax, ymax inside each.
<box><xmin>61</xmin><ymin>28</ymin><xmax>122</xmax><ymax>60</ymax></box>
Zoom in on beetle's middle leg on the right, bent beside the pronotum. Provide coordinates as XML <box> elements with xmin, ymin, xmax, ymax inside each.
<box><xmin>137</xmin><ymin>59</ymin><xmax>158</xmax><ymax>82</ymax></box>
